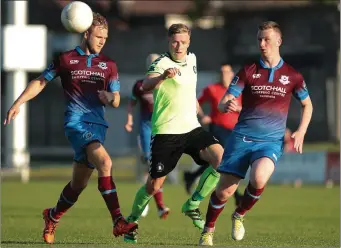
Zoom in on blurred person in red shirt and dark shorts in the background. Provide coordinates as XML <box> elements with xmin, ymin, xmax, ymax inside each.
<box><xmin>184</xmin><ymin>63</ymin><xmax>241</xmax><ymax>205</ymax></box>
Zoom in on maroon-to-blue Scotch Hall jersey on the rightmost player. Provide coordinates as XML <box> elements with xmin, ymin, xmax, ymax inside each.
<box><xmin>228</xmin><ymin>59</ymin><xmax>309</xmax><ymax>140</ymax></box>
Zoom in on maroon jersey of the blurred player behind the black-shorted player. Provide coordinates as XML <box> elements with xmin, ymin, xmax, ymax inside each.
<box><xmin>131</xmin><ymin>80</ymin><xmax>154</xmax><ymax>120</ymax></box>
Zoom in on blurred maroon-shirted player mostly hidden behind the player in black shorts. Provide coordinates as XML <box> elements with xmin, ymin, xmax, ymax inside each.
<box><xmin>125</xmin><ymin>54</ymin><xmax>170</xmax><ymax>219</ymax></box>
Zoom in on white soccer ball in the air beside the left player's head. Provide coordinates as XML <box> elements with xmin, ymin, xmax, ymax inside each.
<box><xmin>61</xmin><ymin>1</ymin><xmax>93</xmax><ymax>33</ymax></box>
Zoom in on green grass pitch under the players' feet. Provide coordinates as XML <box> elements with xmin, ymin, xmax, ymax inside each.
<box><xmin>1</xmin><ymin>180</ymin><xmax>340</xmax><ymax>247</ymax></box>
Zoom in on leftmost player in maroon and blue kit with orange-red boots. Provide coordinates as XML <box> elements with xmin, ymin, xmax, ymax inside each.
<box><xmin>4</xmin><ymin>13</ymin><xmax>137</xmax><ymax>244</ymax></box>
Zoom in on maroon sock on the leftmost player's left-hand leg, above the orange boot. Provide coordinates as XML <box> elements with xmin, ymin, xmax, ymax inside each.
<box><xmin>50</xmin><ymin>182</ymin><xmax>82</xmax><ymax>221</ymax></box>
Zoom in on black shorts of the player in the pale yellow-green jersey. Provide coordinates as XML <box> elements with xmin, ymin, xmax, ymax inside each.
<box><xmin>149</xmin><ymin>127</ymin><xmax>219</xmax><ymax>178</ymax></box>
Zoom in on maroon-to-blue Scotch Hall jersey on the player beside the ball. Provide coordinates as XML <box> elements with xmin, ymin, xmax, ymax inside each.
<box><xmin>43</xmin><ymin>47</ymin><xmax>120</xmax><ymax>126</ymax></box>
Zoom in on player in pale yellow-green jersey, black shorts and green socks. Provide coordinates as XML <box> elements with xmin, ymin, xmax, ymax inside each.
<box><xmin>125</xmin><ymin>24</ymin><xmax>223</xmax><ymax>243</ymax></box>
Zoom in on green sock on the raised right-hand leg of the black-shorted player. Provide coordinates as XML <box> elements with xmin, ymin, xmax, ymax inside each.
<box><xmin>188</xmin><ymin>166</ymin><xmax>220</xmax><ymax>209</ymax></box>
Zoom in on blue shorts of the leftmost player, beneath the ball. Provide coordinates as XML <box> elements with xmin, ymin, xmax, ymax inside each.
<box><xmin>64</xmin><ymin>122</ymin><xmax>107</xmax><ymax>169</ymax></box>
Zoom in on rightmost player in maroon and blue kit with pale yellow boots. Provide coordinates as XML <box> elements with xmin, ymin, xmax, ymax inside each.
<box><xmin>199</xmin><ymin>21</ymin><xmax>313</xmax><ymax>246</ymax></box>
